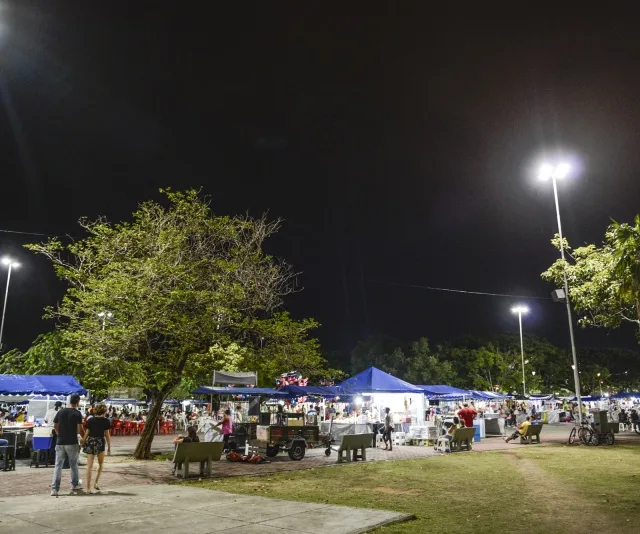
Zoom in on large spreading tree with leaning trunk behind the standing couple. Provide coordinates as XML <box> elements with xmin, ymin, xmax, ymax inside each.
<box><xmin>29</xmin><ymin>190</ymin><xmax>323</xmax><ymax>458</ymax></box>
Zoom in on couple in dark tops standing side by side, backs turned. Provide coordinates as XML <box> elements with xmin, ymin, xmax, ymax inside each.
<box><xmin>51</xmin><ymin>394</ymin><xmax>111</xmax><ymax>497</ymax></box>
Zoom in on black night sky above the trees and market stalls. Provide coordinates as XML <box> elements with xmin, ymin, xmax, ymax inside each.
<box><xmin>0</xmin><ymin>0</ymin><xmax>640</xmax><ymax>358</ymax></box>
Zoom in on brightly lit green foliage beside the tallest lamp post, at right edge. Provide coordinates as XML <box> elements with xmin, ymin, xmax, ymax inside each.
<box><xmin>542</xmin><ymin>215</ymin><xmax>640</xmax><ymax>331</ymax></box>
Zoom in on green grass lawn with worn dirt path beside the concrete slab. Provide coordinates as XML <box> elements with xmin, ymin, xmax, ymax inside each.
<box><xmin>189</xmin><ymin>444</ymin><xmax>640</xmax><ymax>534</ymax></box>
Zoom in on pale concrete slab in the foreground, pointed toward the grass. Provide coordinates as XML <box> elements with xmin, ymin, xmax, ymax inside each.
<box><xmin>0</xmin><ymin>485</ymin><xmax>413</xmax><ymax>534</ymax></box>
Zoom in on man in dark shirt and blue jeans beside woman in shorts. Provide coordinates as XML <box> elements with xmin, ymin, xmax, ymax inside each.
<box><xmin>51</xmin><ymin>393</ymin><xmax>82</xmax><ymax>497</ymax></box>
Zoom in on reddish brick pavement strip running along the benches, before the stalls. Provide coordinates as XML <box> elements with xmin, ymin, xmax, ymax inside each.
<box><xmin>0</xmin><ymin>424</ymin><xmax>640</xmax><ymax>498</ymax></box>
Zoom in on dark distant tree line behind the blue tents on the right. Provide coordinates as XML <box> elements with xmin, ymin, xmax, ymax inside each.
<box><xmin>336</xmin><ymin>334</ymin><xmax>640</xmax><ymax>394</ymax></box>
